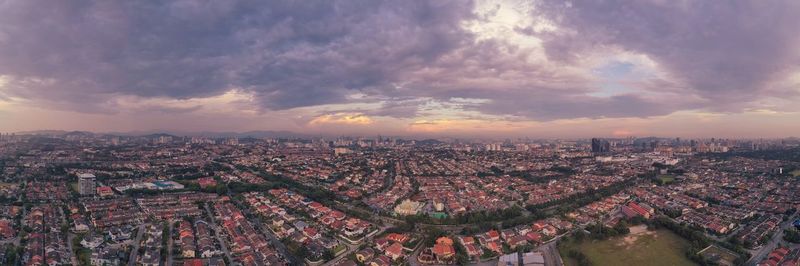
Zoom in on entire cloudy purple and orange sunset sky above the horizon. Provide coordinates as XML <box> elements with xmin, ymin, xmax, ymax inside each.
<box><xmin>0</xmin><ymin>0</ymin><xmax>800</xmax><ymax>138</ymax></box>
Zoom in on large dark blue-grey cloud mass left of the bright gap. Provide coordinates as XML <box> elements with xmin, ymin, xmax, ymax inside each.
<box><xmin>0</xmin><ymin>0</ymin><xmax>472</xmax><ymax>111</ymax></box>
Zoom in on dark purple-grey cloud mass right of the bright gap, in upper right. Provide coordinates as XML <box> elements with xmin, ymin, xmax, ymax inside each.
<box><xmin>539</xmin><ymin>0</ymin><xmax>800</xmax><ymax>111</ymax></box>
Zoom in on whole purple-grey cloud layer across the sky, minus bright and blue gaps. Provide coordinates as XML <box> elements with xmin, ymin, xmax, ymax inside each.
<box><xmin>0</xmin><ymin>0</ymin><xmax>800</xmax><ymax>120</ymax></box>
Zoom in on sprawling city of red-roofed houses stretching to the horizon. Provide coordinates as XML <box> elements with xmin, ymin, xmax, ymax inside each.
<box><xmin>0</xmin><ymin>134</ymin><xmax>800</xmax><ymax>265</ymax></box>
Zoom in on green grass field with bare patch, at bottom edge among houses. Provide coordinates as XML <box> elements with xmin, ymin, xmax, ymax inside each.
<box><xmin>559</xmin><ymin>228</ymin><xmax>696</xmax><ymax>266</ymax></box>
